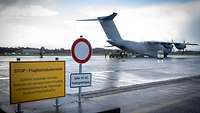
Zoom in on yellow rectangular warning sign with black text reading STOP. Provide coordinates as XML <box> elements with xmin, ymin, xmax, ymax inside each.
<box><xmin>10</xmin><ymin>61</ymin><xmax>65</xmax><ymax>104</ymax></box>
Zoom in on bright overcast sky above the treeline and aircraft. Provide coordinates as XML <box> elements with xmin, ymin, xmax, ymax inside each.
<box><xmin>0</xmin><ymin>0</ymin><xmax>200</xmax><ymax>50</ymax></box>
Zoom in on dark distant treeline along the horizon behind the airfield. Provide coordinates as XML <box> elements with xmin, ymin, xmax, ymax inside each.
<box><xmin>0</xmin><ymin>47</ymin><xmax>200</xmax><ymax>56</ymax></box>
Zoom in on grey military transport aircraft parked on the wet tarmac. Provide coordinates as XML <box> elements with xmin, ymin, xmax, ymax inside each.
<box><xmin>78</xmin><ymin>13</ymin><xmax>198</xmax><ymax>58</ymax></box>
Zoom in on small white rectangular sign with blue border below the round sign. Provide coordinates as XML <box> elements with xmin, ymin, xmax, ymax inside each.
<box><xmin>70</xmin><ymin>73</ymin><xmax>92</xmax><ymax>88</ymax></box>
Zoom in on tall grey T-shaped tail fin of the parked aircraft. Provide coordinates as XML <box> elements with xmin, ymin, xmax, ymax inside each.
<box><xmin>78</xmin><ymin>13</ymin><xmax>122</xmax><ymax>41</ymax></box>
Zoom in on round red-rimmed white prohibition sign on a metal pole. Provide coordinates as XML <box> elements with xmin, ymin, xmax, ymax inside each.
<box><xmin>71</xmin><ymin>36</ymin><xmax>92</xmax><ymax>64</ymax></box>
